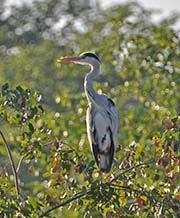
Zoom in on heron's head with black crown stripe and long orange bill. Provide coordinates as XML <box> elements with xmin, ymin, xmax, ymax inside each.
<box><xmin>58</xmin><ymin>51</ymin><xmax>100</xmax><ymax>65</ymax></box>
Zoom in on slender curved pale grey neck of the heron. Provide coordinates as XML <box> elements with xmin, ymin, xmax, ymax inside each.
<box><xmin>84</xmin><ymin>63</ymin><xmax>100</xmax><ymax>104</ymax></box>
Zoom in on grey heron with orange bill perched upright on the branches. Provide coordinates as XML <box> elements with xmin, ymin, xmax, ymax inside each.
<box><xmin>58</xmin><ymin>51</ymin><xmax>118</xmax><ymax>173</ymax></box>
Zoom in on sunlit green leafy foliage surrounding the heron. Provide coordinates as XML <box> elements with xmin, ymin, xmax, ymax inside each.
<box><xmin>0</xmin><ymin>0</ymin><xmax>180</xmax><ymax>218</ymax></box>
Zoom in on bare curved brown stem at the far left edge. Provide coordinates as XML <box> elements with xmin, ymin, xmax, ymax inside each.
<box><xmin>0</xmin><ymin>130</ymin><xmax>20</xmax><ymax>200</ymax></box>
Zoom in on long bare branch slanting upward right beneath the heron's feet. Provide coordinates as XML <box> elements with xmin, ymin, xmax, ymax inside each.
<box><xmin>39</xmin><ymin>160</ymin><xmax>155</xmax><ymax>218</ymax></box>
